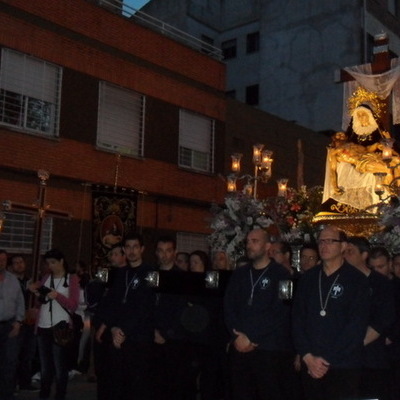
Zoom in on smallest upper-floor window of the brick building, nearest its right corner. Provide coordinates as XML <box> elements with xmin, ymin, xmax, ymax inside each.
<box><xmin>179</xmin><ymin>110</ymin><xmax>214</xmax><ymax>172</ymax></box>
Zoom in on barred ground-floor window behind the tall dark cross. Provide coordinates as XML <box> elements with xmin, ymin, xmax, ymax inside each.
<box><xmin>0</xmin><ymin>212</ymin><xmax>53</xmax><ymax>254</ymax></box>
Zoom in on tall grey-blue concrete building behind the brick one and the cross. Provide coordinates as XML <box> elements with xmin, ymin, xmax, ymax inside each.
<box><xmin>141</xmin><ymin>0</ymin><xmax>400</xmax><ymax>131</ymax></box>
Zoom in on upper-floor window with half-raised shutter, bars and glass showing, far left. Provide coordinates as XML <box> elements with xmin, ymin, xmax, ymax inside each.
<box><xmin>0</xmin><ymin>49</ymin><xmax>62</xmax><ymax>136</ymax></box>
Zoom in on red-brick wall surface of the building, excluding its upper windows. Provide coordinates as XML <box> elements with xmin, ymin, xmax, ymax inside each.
<box><xmin>0</xmin><ymin>0</ymin><xmax>226</xmax><ymax>261</ymax></box>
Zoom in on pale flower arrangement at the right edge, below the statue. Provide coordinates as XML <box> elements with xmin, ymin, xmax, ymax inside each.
<box><xmin>370</xmin><ymin>197</ymin><xmax>400</xmax><ymax>254</ymax></box>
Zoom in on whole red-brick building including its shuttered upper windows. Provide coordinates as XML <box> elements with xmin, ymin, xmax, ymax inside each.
<box><xmin>0</xmin><ymin>0</ymin><xmax>226</xmax><ymax>268</ymax></box>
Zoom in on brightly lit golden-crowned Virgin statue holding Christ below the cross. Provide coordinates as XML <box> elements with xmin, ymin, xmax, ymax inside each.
<box><xmin>323</xmin><ymin>90</ymin><xmax>400</xmax><ymax>210</ymax></box>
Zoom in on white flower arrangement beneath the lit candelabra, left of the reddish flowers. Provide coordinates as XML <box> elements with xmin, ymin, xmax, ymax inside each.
<box><xmin>209</xmin><ymin>192</ymin><xmax>274</xmax><ymax>260</ymax></box>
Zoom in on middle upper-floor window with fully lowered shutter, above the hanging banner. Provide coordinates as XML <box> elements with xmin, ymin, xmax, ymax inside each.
<box><xmin>97</xmin><ymin>82</ymin><xmax>145</xmax><ymax>156</ymax></box>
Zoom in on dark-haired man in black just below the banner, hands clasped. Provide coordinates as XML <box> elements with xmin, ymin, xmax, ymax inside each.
<box><xmin>104</xmin><ymin>234</ymin><xmax>155</xmax><ymax>400</ymax></box>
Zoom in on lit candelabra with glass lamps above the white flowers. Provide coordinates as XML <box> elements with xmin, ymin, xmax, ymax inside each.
<box><xmin>227</xmin><ymin>144</ymin><xmax>274</xmax><ymax>199</ymax></box>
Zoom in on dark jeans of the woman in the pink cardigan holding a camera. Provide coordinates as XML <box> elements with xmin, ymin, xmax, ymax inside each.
<box><xmin>38</xmin><ymin>328</ymin><xmax>68</xmax><ymax>400</ymax></box>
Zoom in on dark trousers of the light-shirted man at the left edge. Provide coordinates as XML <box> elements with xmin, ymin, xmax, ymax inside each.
<box><xmin>0</xmin><ymin>322</ymin><xmax>18</xmax><ymax>400</ymax></box>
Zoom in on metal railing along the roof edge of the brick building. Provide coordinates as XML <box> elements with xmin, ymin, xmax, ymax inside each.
<box><xmin>89</xmin><ymin>0</ymin><xmax>223</xmax><ymax>60</ymax></box>
